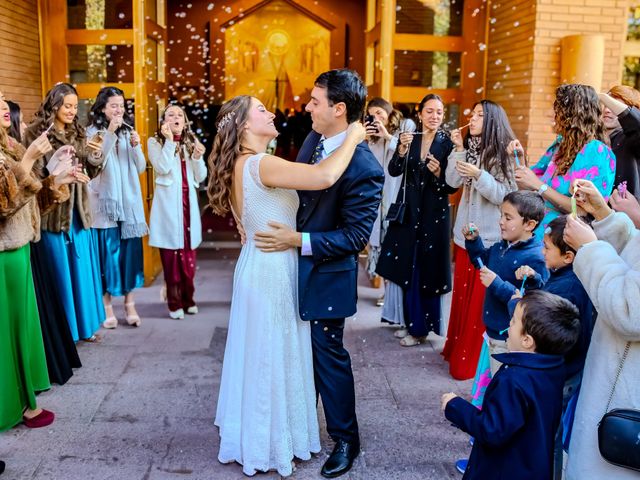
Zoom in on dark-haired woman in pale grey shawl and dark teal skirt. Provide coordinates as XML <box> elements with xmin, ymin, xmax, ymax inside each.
<box><xmin>87</xmin><ymin>87</ymin><xmax>149</xmax><ymax>328</ymax></box>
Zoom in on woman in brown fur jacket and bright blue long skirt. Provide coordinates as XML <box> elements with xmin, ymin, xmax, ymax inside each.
<box><xmin>23</xmin><ymin>83</ymin><xmax>104</xmax><ymax>342</ymax></box>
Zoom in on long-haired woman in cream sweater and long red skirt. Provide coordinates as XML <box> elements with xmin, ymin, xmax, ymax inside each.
<box><xmin>442</xmin><ymin>100</ymin><xmax>517</xmax><ymax>380</ymax></box>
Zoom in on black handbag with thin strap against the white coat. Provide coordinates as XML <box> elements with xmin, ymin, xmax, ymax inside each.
<box><xmin>598</xmin><ymin>342</ymin><xmax>640</xmax><ymax>471</ymax></box>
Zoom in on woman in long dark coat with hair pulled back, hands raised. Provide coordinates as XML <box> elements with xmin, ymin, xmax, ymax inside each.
<box><xmin>376</xmin><ymin>94</ymin><xmax>456</xmax><ymax>347</ymax></box>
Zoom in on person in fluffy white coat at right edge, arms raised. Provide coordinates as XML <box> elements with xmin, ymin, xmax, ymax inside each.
<box><xmin>564</xmin><ymin>180</ymin><xmax>640</xmax><ymax>480</ymax></box>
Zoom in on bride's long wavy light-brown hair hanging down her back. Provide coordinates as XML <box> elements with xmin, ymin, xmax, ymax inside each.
<box><xmin>207</xmin><ymin>95</ymin><xmax>253</xmax><ymax>216</ymax></box>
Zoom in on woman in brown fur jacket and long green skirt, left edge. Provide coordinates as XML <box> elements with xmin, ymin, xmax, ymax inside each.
<box><xmin>0</xmin><ymin>93</ymin><xmax>89</xmax><ymax>431</ymax></box>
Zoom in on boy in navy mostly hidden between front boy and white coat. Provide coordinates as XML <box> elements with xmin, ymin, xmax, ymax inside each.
<box><xmin>516</xmin><ymin>215</ymin><xmax>594</xmax><ymax>480</ymax></box>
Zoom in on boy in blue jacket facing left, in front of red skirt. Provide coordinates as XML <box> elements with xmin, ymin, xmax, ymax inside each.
<box><xmin>462</xmin><ymin>191</ymin><xmax>548</xmax><ymax>375</ymax></box>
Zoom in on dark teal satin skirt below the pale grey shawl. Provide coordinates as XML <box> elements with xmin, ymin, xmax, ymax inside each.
<box><xmin>94</xmin><ymin>225</ymin><xmax>144</xmax><ymax>297</ymax></box>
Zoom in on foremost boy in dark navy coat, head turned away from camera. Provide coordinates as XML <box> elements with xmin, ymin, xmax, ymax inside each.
<box><xmin>442</xmin><ymin>290</ymin><xmax>580</xmax><ymax>480</ymax></box>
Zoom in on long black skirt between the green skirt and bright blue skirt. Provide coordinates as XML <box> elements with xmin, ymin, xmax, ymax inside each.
<box><xmin>31</xmin><ymin>243</ymin><xmax>82</xmax><ymax>385</ymax></box>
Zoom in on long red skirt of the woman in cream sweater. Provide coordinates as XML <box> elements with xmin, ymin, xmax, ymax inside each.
<box><xmin>442</xmin><ymin>245</ymin><xmax>485</xmax><ymax>380</ymax></box>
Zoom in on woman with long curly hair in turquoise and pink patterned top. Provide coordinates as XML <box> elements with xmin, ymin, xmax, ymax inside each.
<box><xmin>511</xmin><ymin>84</ymin><xmax>616</xmax><ymax>238</ymax></box>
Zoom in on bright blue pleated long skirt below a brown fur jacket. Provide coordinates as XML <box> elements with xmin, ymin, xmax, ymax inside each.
<box><xmin>40</xmin><ymin>214</ymin><xmax>105</xmax><ymax>342</ymax></box>
